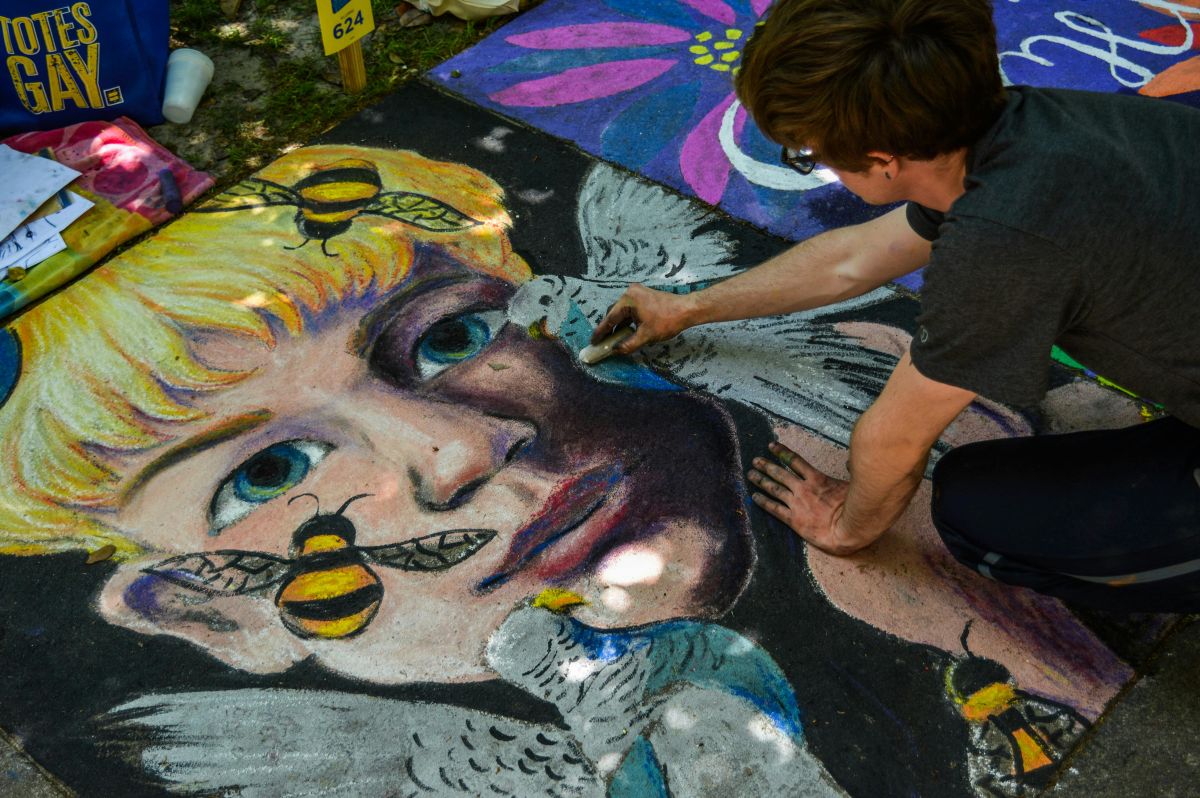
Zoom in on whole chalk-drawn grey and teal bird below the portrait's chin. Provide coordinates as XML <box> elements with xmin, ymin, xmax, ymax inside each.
<box><xmin>109</xmin><ymin>604</ymin><xmax>842</xmax><ymax>798</ymax></box>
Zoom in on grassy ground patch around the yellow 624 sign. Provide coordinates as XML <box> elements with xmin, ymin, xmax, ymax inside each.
<box><xmin>164</xmin><ymin>0</ymin><xmax>504</xmax><ymax>185</ymax></box>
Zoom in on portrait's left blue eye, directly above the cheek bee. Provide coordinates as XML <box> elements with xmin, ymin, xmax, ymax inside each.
<box><xmin>209</xmin><ymin>440</ymin><xmax>332</xmax><ymax>534</ymax></box>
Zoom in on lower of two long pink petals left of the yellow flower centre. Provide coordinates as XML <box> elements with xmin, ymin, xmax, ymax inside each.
<box><xmin>490</xmin><ymin>58</ymin><xmax>678</xmax><ymax>108</ymax></box>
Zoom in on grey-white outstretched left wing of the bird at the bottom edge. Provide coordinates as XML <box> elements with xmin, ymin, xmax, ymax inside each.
<box><xmin>112</xmin><ymin>689</ymin><xmax>605</xmax><ymax>798</ymax></box>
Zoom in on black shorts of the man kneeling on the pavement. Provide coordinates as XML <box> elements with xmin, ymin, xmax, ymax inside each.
<box><xmin>932</xmin><ymin>419</ymin><xmax>1200</xmax><ymax>612</ymax></box>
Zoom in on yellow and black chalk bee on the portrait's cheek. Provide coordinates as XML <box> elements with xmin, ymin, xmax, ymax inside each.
<box><xmin>144</xmin><ymin>493</ymin><xmax>496</xmax><ymax>640</ymax></box>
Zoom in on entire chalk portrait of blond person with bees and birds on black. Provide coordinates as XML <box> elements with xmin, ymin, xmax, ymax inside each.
<box><xmin>0</xmin><ymin>85</ymin><xmax>1135</xmax><ymax>798</ymax></box>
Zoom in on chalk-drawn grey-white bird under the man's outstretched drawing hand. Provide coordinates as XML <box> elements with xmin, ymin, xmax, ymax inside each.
<box><xmin>509</xmin><ymin>164</ymin><xmax>896</xmax><ymax>446</ymax></box>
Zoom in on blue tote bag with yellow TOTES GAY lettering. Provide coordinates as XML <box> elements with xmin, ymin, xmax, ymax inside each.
<box><xmin>0</xmin><ymin>0</ymin><xmax>170</xmax><ymax>133</ymax></box>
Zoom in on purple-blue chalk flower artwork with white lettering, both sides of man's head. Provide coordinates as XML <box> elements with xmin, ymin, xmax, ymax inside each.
<box><xmin>430</xmin><ymin>0</ymin><xmax>1200</xmax><ymax>288</ymax></box>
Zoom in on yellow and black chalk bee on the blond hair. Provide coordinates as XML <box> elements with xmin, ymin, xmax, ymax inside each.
<box><xmin>196</xmin><ymin>158</ymin><xmax>479</xmax><ymax>257</ymax></box>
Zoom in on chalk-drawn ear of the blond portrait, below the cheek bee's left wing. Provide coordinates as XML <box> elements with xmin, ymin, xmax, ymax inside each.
<box><xmin>97</xmin><ymin>559</ymin><xmax>311</xmax><ymax>673</ymax></box>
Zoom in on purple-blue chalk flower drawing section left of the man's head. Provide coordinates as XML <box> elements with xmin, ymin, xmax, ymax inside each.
<box><xmin>433</xmin><ymin>0</ymin><xmax>870</xmax><ymax>238</ymax></box>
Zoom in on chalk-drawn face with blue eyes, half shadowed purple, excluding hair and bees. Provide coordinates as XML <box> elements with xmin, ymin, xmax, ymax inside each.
<box><xmin>101</xmin><ymin>252</ymin><xmax>752</xmax><ymax>683</ymax></box>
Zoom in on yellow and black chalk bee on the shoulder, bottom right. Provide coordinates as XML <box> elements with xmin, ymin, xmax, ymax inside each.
<box><xmin>946</xmin><ymin>622</ymin><xmax>1090</xmax><ymax>798</ymax></box>
